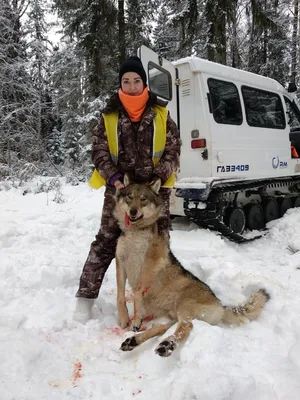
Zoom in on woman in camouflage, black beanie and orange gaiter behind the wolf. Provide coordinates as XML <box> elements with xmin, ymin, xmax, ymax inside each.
<box><xmin>74</xmin><ymin>57</ymin><xmax>181</xmax><ymax>323</ymax></box>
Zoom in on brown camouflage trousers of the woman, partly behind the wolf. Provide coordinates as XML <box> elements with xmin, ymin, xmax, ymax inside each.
<box><xmin>76</xmin><ymin>187</ymin><xmax>171</xmax><ymax>299</ymax></box>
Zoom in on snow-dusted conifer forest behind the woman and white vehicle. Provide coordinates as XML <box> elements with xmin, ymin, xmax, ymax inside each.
<box><xmin>0</xmin><ymin>0</ymin><xmax>300</xmax><ymax>180</ymax></box>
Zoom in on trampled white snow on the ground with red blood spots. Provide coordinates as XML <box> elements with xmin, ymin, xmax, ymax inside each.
<box><xmin>0</xmin><ymin>182</ymin><xmax>300</xmax><ymax>400</ymax></box>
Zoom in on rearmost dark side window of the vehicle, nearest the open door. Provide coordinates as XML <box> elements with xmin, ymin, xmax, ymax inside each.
<box><xmin>207</xmin><ymin>78</ymin><xmax>243</xmax><ymax>125</ymax></box>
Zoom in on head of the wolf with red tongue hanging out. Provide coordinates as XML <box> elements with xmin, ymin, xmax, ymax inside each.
<box><xmin>114</xmin><ymin>175</ymin><xmax>163</xmax><ymax>230</ymax></box>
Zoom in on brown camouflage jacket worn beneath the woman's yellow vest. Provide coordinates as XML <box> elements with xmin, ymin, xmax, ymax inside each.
<box><xmin>92</xmin><ymin>92</ymin><xmax>181</xmax><ymax>183</ymax></box>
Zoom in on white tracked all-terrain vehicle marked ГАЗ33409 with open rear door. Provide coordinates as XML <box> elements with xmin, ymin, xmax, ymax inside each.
<box><xmin>138</xmin><ymin>46</ymin><xmax>300</xmax><ymax>242</ymax></box>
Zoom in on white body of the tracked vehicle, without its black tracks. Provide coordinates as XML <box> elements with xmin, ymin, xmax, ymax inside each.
<box><xmin>139</xmin><ymin>46</ymin><xmax>300</xmax><ymax>222</ymax></box>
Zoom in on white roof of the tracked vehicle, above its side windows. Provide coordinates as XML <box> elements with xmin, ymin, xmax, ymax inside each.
<box><xmin>172</xmin><ymin>57</ymin><xmax>287</xmax><ymax>93</ymax></box>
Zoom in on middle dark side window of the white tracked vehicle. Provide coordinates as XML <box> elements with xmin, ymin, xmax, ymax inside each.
<box><xmin>242</xmin><ymin>86</ymin><xmax>286</xmax><ymax>129</ymax></box>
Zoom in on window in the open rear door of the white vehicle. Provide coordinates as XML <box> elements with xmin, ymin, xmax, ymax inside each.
<box><xmin>148</xmin><ymin>62</ymin><xmax>172</xmax><ymax>100</ymax></box>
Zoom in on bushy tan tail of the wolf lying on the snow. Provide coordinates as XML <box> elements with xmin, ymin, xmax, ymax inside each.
<box><xmin>222</xmin><ymin>289</ymin><xmax>270</xmax><ymax>325</ymax></box>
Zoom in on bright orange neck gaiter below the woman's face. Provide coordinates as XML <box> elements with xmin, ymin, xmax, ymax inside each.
<box><xmin>118</xmin><ymin>86</ymin><xmax>149</xmax><ymax>122</ymax></box>
